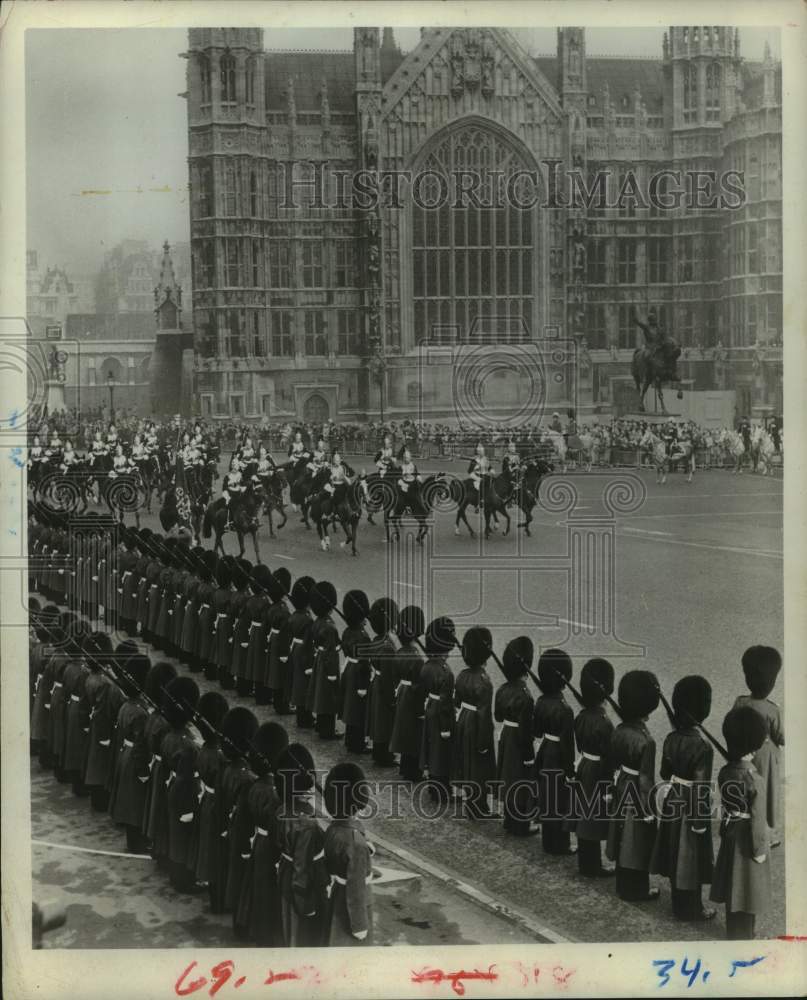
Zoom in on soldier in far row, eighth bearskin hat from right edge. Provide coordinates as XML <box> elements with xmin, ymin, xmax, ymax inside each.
<box><xmin>451</xmin><ymin>627</ymin><xmax>496</xmax><ymax>819</ymax></box>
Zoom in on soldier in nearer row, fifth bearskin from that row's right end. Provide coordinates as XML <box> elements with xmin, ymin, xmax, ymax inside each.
<box><xmin>191</xmin><ymin>691</ymin><xmax>230</xmax><ymax>913</ymax></box>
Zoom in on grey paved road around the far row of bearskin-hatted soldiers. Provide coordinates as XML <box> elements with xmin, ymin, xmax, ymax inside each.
<box><xmin>34</xmin><ymin>462</ymin><xmax>785</xmax><ymax>941</ymax></box>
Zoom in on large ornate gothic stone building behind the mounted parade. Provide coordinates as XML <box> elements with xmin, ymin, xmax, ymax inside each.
<box><xmin>185</xmin><ymin>27</ymin><xmax>782</xmax><ymax>420</ymax></box>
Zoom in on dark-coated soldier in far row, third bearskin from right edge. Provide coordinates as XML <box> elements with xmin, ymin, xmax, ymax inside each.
<box><xmin>650</xmin><ymin>675</ymin><xmax>716</xmax><ymax>921</ymax></box>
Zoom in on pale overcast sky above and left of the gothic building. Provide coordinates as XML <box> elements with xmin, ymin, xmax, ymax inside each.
<box><xmin>26</xmin><ymin>27</ymin><xmax>779</xmax><ymax>274</ymax></box>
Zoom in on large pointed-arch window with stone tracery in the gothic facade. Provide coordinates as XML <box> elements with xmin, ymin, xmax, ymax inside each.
<box><xmin>412</xmin><ymin>124</ymin><xmax>537</xmax><ymax>341</ymax></box>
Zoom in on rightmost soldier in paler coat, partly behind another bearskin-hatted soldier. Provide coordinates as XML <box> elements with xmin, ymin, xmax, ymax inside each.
<box><xmin>734</xmin><ymin>646</ymin><xmax>785</xmax><ymax>847</ymax></box>
